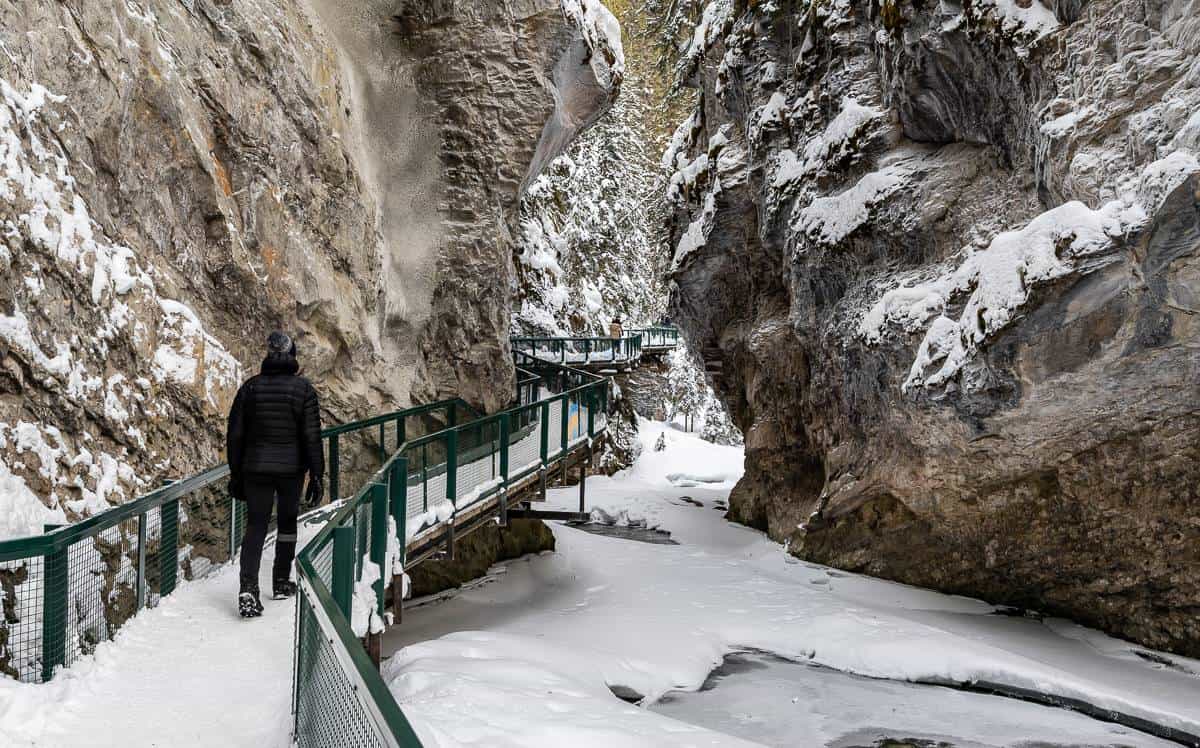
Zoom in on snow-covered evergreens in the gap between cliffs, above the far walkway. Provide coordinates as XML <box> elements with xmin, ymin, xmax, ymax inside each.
<box><xmin>512</xmin><ymin>63</ymin><xmax>667</xmax><ymax>335</ymax></box>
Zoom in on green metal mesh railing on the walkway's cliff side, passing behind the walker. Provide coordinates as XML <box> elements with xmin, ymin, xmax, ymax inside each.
<box><xmin>0</xmin><ymin>400</ymin><xmax>463</xmax><ymax>682</ymax></box>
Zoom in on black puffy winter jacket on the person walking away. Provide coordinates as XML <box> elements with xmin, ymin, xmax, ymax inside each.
<box><xmin>226</xmin><ymin>355</ymin><xmax>325</xmax><ymax>480</ymax></box>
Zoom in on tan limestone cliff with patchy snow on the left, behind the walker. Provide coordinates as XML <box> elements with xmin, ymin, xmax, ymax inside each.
<box><xmin>0</xmin><ymin>0</ymin><xmax>619</xmax><ymax>537</ymax></box>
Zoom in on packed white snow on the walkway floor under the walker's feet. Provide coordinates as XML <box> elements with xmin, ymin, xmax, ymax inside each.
<box><xmin>0</xmin><ymin>546</ymin><xmax>295</xmax><ymax>748</ymax></box>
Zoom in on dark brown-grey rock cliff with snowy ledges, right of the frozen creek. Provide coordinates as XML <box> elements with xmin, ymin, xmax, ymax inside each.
<box><xmin>673</xmin><ymin>0</ymin><xmax>1200</xmax><ymax>656</ymax></box>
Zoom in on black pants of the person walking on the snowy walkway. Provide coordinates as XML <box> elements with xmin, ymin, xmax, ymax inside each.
<box><xmin>241</xmin><ymin>473</ymin><xmax>304</xmax><ymax>590</ymax></box>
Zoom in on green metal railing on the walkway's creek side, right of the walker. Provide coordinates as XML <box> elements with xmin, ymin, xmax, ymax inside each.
<box><xmin>293</xmin><ymin>353</ymin><xmax>608</xmax><ymax>748</ymax></box>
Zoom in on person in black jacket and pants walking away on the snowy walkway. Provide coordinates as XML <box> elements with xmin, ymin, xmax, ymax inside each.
<box><xmin>226</xmin><ymin>333</ymin><xmax>325</xmax><ymax>618</ymax></box>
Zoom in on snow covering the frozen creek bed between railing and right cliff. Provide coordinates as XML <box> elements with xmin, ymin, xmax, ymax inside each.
<box><xmin>384</xmin><ymin>421</ymin><xmax>1200</xmax><ymax>746</ymax></box>
